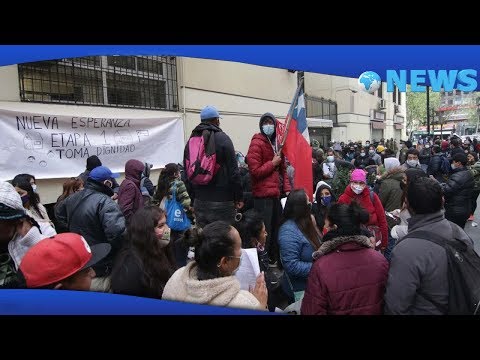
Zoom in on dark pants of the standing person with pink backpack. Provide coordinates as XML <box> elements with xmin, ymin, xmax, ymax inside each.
<box><xmin>193</xmin><ymin>199</ymin><xmax>235</xmax><ymax>227</ymax></box>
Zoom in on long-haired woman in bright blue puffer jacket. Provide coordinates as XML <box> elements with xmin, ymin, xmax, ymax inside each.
<box><xmin>278</xmin><ymin>189</ymin><xmax>321</xmax><ymax>300</ymax></box>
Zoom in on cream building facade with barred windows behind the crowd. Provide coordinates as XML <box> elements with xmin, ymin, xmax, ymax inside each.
<box><xmin>0</xmin><ymin>56</ymin><xmax>405</xmax><ymax>204</ymax></box>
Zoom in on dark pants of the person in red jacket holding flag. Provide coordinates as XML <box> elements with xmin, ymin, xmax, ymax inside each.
<box><xmin>253</xmin><ymin>198</ymin><xmax>282</xmax><ymax>263</ymax></box>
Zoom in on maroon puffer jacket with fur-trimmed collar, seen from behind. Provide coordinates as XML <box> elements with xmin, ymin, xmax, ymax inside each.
<box><xmin>301</xmin><ymin>232</ymin><xmax>388</xmax><ymax>315</ymax></box>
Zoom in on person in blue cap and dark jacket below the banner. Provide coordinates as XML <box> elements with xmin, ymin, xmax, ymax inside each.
<box><xmin>55</xmin><ymin>166</ymin><xmax>125</xmax><ymax>291</ymax></box>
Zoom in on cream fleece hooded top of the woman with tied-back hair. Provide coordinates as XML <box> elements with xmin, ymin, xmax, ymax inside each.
<box><xmin>162</xmin><ymin>261</ymin><xmax>265</xmax><ymax>310</ymax></box>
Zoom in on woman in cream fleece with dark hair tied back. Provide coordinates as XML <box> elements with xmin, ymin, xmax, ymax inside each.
<box><xmin>162</xmin><ymin>221</ymin><xmax>268</xmax><ymax>310</ymax></box>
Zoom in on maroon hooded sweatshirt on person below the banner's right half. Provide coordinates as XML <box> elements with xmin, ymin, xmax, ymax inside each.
<box><xmin>118</xmin><ymin>160</ymin><xmax>145</xmax><ymax>222</ymax></box>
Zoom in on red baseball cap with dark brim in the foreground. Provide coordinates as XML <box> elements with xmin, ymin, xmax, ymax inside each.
<box><xmin>20</xmin><ymin>233</ymin><xmax>111</xmax><ymax>288</ymax></box>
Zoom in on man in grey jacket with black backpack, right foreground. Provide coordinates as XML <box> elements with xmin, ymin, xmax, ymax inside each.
<box><xmin>385</xmin><ymin>177</ymin><xmax>473</xmax><ymax>315</ymax></box>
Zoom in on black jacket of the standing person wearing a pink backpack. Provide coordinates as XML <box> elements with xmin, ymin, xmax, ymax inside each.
<box><xmin>183</xmin><ymin>123</ymin><xmax>243</xmax><ymax>202</ymax></box>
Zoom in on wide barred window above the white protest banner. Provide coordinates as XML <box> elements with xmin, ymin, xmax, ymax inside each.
<box><xmin>18</xmin><ymin>56</ymin><xmax>178</xmax><ymax>111</ymax></box>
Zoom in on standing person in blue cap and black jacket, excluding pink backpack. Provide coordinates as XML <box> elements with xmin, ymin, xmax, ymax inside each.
<box><xmin>183</xmin><ymin>106</ymin><xmax>243</xmax><ymax>227</ymax></box>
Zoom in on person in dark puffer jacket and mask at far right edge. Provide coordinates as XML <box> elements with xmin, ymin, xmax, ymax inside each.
<box><xmin>441</xmin><ymin>153</ymin><xmax>475</xmax><ymax>229</ymax></box>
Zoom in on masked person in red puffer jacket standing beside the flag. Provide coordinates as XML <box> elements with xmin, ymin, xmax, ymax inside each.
<box><xmin>247</xmin><ymin>113</ymin><xmax>290</xmax><ymax>262</ymax></box>
